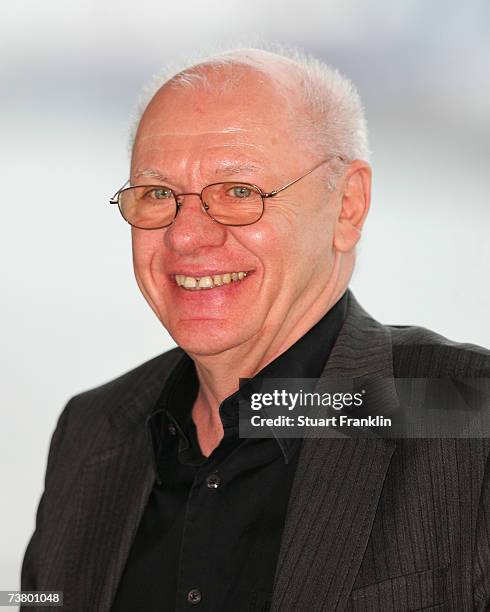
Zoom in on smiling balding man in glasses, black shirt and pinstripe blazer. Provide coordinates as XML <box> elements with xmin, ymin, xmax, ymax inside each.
<box><xmin>22</xmin><ymin>49</ymin><xmax>490</xmax><ymax>612</ymax></box>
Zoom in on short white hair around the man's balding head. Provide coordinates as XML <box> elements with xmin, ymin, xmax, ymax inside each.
<box><xmin>130</xmin><ymin>45</ymin><xmax>369</xmax><ymax>175</ymax></box>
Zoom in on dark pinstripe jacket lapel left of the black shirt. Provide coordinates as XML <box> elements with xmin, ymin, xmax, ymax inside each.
<box><xmin>64</xmin><ymin>351</ymin><xmax>182</xmax><ymax>612</ymax></box>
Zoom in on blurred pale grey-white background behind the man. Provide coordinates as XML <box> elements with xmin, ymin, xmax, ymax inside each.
<box><xmin>0</xmin><ymin>0</ymin><xmax>490</xmax><ymax>589</ymax></box>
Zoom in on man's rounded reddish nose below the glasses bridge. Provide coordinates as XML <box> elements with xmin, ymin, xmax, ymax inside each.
<box><xmin>164</xmin><ymin>193</ymin><xmax>227</xmax><ymax>255</ymax></box>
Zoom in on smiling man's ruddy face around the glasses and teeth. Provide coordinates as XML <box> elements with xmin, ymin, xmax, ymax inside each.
<box><xmin>131</xmin><ymin>71</ymin><xmax>337</xmax><ymax>355</ymax></box>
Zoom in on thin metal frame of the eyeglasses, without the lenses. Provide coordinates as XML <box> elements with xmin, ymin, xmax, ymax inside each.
<box><xmin>109</xmin><ymin>155</ymin><xmax>346</xmax><ymax>231</ymax></box>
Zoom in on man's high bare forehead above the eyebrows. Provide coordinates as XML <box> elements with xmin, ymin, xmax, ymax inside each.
<box><xmin>131</xmin><ymin>71</ymin><xmax>296</xmax><ymax>152</ymax></box>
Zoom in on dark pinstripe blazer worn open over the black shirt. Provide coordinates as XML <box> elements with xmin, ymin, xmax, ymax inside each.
<box><xmin>22</xmin><ymin>293</ymin><xmax>490</xmax><ymax>612</ymax></box>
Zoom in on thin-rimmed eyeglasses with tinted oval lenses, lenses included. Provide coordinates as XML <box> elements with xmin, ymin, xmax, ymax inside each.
<box><xmin>109</xmin><ymin>155</ymin><xmax>344</xmax><ymax>230</ymax></box>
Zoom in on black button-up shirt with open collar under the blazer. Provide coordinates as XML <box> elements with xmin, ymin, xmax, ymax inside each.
<box><xmin>112</xmin><ymin>294</ymin><xmax>347</xmax><ymax>612</ymax></box>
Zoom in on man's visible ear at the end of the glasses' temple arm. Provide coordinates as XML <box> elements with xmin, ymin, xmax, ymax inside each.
<box><xmin>333</xmin><ymin>160</ymin><xmax>371</xmax><ymax>253</ymax></box>
